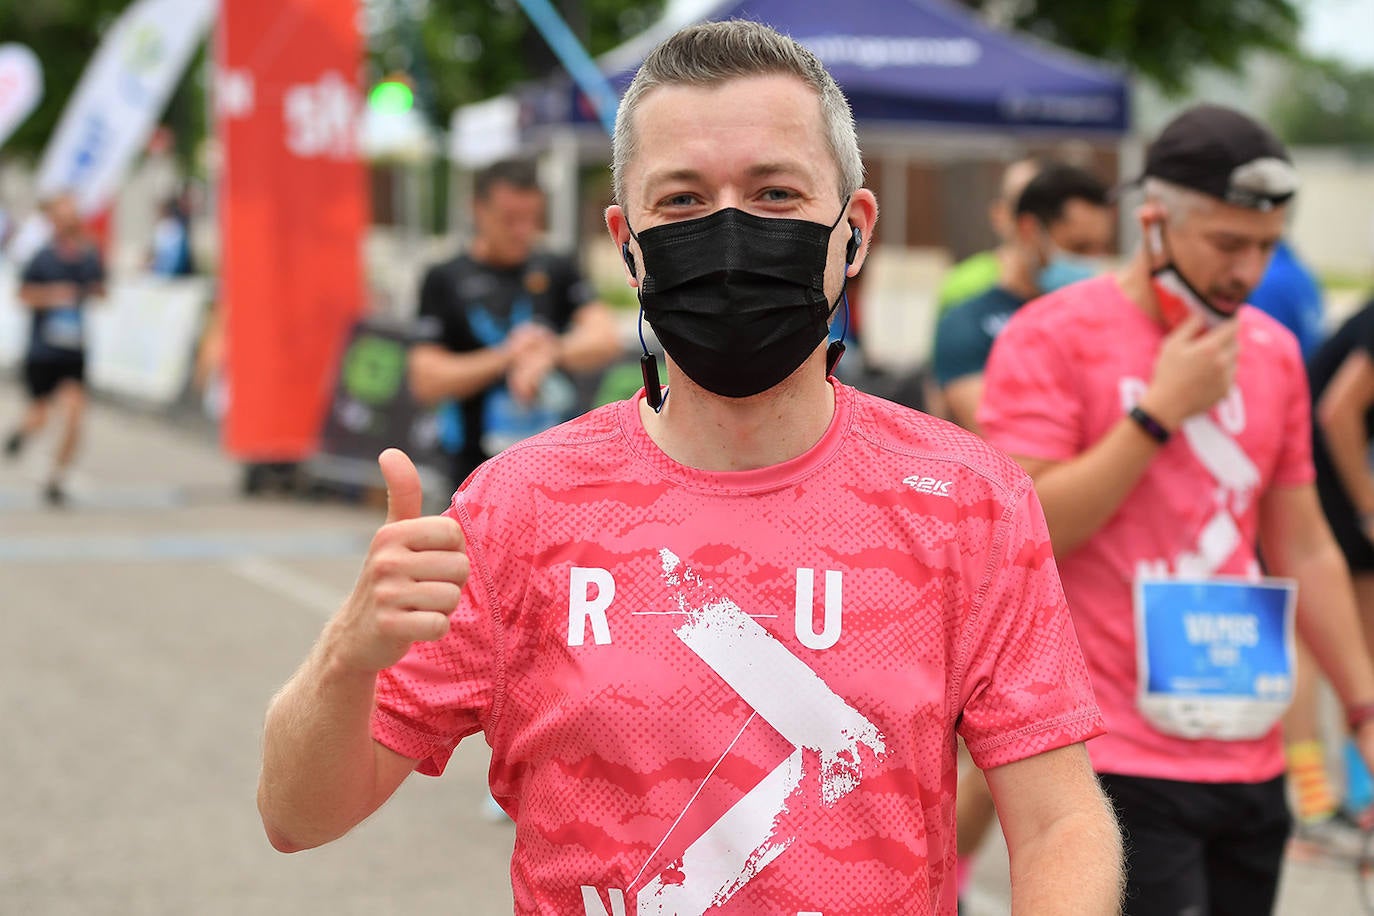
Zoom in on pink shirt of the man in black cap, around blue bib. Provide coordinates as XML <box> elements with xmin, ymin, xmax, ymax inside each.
<box><xmin>978</xmin><ymin>276</ymin><xmax>1314</xmax><ymax>783</ymax></box>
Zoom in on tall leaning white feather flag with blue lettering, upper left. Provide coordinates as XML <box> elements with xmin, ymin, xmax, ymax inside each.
<box><xmin>38</xmin><ymin>0</ymin><xmax>217</xmax><ymax>216</ymax></box>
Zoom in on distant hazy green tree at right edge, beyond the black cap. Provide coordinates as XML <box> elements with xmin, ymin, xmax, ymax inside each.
<box><xmin>1270</xmin><ymin>58</ymin><xmax>1374</xmax><ymax>148</ymax></box>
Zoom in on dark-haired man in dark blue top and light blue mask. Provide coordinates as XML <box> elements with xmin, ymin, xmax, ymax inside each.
<box><xmin>932</xmin><ymin>165</ymin><xmax>1114</xmax><ymax>433</ymax></box>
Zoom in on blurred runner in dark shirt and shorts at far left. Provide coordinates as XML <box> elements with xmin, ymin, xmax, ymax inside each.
<box><xmin>4</xmin><ymin>196</ymin><xmax>104</xmax><ymax>505</ymax></box>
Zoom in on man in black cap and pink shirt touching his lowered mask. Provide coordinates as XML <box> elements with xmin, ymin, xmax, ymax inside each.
<box><xmin>978</xmin><ymin>106</ymin><xmax>1374</xmax><ymax>915</ymax></box>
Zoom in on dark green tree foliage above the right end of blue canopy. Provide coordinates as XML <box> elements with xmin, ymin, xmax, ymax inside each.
<box><xmin>963</xmin><ymin>0</ymin><xmax>1301</xmax><ymax>93</ymax></box>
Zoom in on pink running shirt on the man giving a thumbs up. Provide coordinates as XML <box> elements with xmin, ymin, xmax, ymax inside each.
<box><xmin>374</xmin><ymin>383</ymin><xmax>1101</xmax><ymax>916</ymax></box>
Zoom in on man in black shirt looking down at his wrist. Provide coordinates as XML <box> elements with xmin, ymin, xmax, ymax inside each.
<box><xmin>409</xmin><ymin>161</ymin><xmax>621</xmax><ymax>486</ymax></box>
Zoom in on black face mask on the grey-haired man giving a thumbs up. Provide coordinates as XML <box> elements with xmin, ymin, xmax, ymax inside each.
<box><xmin>632</xmin><ymin>202</ymin><xmax>848</xmax><ymax>398</ymax></box>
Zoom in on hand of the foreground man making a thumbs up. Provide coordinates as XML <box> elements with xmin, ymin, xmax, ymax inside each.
<box><xmin>324</xmin><ymin>449</ymin><xmax>469</xmax><ymax>672</ymax></box>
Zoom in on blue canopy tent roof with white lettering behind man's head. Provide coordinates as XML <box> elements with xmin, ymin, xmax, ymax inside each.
<box><xmin>521</xmin><ymin>0</ymin><xmax>1129</xmax><ymax>136</ymax></box>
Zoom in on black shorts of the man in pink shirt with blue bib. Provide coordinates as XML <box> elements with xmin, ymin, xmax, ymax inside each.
<box><xmin>1098</xmin><ymin>773</ymin><xmax>1292</xmax><ymax>916</ymax></box>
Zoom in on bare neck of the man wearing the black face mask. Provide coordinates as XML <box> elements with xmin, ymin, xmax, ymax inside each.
<box><xmin>639</xmin><ymin>352</ymin><xmax>835</xmax><ymax>471</ymax></box>
